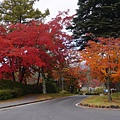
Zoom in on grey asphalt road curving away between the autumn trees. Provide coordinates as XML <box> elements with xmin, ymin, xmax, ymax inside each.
<box><xmin>0</xmin><ymin>95</ymin><xmax>120</xmax><ymax>120</ymax></box>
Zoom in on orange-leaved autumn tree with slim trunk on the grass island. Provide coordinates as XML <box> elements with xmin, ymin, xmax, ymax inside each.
<box><xmin>81</xmin><ymin>38</ymin><xmax>120</xmax><ymax>100</ymax></box>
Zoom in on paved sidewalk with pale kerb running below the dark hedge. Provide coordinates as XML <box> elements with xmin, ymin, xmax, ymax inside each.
<box><xmin>0</xmin><ymin>94</ymin><xmax>42</xmax><ymax>109</ymax></box>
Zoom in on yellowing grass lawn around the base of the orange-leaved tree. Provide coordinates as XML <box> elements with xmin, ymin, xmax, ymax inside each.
<box><xmin>81</xmin><ymin>93</ymin><xmax>120</xmax><ymax>108</ymax></box>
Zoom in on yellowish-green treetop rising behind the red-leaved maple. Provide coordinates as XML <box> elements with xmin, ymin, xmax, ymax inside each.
<box><xmin>0</xmin><ymin>0</ymin><xmax>49</xmax><ymax>23</ymax></box>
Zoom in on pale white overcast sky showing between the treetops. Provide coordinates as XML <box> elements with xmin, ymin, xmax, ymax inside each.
<box><xmin>0</xmin><ymin>0</ymin><xmax>78</xmax><ymax>19</ymax></box>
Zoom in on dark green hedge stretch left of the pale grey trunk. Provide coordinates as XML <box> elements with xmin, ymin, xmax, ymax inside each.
<box><xmin>0</xmin><ymin>80</ymin><xmax>39</xmax><ymax>100</ymax></box>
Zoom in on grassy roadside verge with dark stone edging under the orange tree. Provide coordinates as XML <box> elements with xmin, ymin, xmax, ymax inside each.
<box><xmin>76</xmin><ymin>95</ymin><xmax>120</xmax><ymax>110</ymax></box>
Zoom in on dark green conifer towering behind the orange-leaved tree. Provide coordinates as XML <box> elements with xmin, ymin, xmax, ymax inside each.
<box><xmin>69</xmin><ymin>0</ymin><xmax>120</xmax><ymax>38</ymax></box>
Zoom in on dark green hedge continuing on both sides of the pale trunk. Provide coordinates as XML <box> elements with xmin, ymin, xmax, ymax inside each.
<box><xmin>0</xmin><ymin>80</ymin><xmax>59</xmax><ymax>100</ymax></box>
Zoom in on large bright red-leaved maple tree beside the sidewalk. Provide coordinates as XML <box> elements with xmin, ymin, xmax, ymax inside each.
<box><xmin>0</xmin><ymin>12</ymin><xmax>71</xmax><ymax>93</ymax></box>
